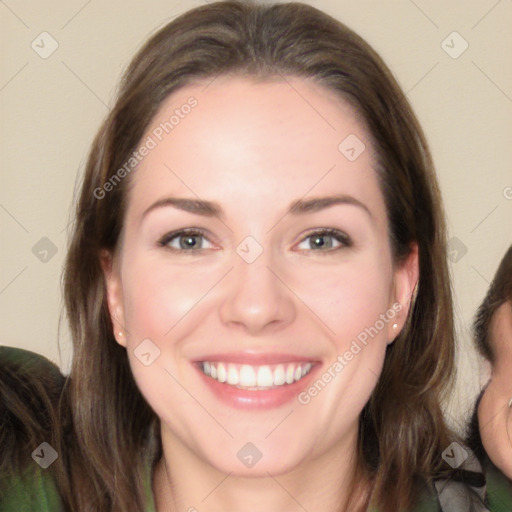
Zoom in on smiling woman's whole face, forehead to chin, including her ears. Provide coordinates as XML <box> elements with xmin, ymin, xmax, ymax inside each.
<box><xmin>102</xmin><ymin>77</ymin><xmax>417</xmax><ymax>475</ymax></box>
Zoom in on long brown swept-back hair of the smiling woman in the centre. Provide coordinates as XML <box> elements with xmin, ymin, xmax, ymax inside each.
<box><xmin>57</xmin><ymin>1</ymin><xmax>460</xmax><ymax>512</ymax></box>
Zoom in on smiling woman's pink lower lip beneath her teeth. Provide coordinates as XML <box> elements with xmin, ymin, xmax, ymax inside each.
<box><xmin>194</xmin><ymin>364</ymin><xmax>320</xmax><ymax>409</ymax></box>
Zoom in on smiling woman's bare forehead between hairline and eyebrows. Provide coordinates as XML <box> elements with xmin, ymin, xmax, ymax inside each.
<box><xmin>128</xmin><ymin>77</ymin><xmax>383</xmax><ymax>227</ymax></box>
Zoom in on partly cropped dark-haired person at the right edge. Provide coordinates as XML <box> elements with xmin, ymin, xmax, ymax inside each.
<box><xmin>469</xmin><ymin>246</ymin><xmax>512</xmax><ymax>510</ymax></box>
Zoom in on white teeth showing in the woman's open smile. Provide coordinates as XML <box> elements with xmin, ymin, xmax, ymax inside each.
<box><xmin>199</xmin><ymin>361</ymin><xmax>313</xmax><ymax>391</ymax></box>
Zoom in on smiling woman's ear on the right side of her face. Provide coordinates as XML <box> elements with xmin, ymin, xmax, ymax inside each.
<box><xmin>387</xmin><ymin>243</ymin><xmax>419</xmax><ymax>344</ymax></box>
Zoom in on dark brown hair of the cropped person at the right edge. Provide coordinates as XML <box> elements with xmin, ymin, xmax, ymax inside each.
<box><xmin>473</xmin><ymin>246</ymin><xmax>512</xmax><ymax>364</ymax></box>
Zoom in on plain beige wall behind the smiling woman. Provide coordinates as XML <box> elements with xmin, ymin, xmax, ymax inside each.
<box><xmin>0</xmin><ymin>0</ymin><xmax>512</xmax><ymax>432</ymax></box>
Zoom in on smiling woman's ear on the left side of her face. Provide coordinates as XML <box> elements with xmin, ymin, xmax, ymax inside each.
<box><xmin>100</xmin><ymin>249</ymin><xmax>126</xmax><ymax>347</ymax></box>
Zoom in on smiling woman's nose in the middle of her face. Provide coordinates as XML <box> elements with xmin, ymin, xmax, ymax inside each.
<box><xmin>219</xmin><ymin>250</ymin><xmax>296</xmax><ymax>335</ymax></box>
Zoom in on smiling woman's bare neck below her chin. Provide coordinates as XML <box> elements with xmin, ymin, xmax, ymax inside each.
<box><xmin>153</xmin><ymin>424</ymin><xmax>371</xmax><ymax>512</ymax></box>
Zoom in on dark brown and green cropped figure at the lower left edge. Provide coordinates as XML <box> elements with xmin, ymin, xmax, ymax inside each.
<box><xmin>0</xmin><ymin>346</ymin><xmax>69</xmax><ymax>512</ymax></box>
